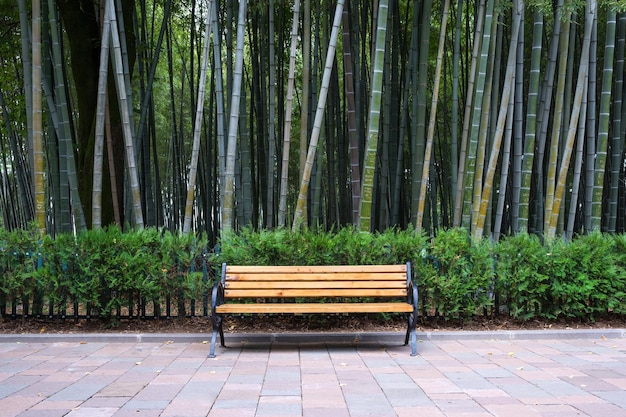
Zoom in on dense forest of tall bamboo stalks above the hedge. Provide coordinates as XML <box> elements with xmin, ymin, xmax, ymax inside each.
<box><xmin>0</xmin><ymin>0</ymin><xmax>626</xmax><ymax>241</ymax></box>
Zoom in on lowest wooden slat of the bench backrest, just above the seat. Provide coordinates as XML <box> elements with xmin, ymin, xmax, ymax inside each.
<box><xmin>224</xmin><ymin>288</ymin><xmax>407</xmax><ymax>298</ymax></box>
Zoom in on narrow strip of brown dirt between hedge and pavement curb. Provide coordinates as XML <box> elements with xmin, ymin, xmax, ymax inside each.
<box><xmin>0</xmin><ymin>314</ymin><xmax>626</xmax><ymax>334</ymax></box>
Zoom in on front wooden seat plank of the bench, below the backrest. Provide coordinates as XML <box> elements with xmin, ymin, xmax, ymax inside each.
<box><xmin>216</xmin><ymin>303</ymin><xmax>413</xmax><ymax>314</ymax></box>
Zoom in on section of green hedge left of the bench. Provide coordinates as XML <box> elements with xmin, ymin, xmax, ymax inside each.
<box><xmin>0</xmin><ymin>227</ymin><xmax>210</xmax><ymax>318</ymax></box>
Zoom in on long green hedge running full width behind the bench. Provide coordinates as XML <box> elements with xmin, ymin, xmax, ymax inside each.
<box><xmin>0</xmin><ymin>227</ymin><xmax>626</xmax><ymax>324</ymax></box>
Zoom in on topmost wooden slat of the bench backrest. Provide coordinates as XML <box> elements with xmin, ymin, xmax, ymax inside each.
<box><xmin>226</xmin><ymin>265</ymin><xmax>407</xmax><ymax>274</ymax></box>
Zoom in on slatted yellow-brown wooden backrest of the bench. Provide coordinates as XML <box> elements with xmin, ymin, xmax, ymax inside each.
<box><xmin>222</xmin><ymin>263</ymin><xmax>410</xmax><ymax>298</ymax></box>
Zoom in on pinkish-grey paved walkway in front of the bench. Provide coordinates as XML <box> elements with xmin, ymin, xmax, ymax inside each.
<box><xmin>0</xmin><ymin>330</ymin><xmax>626</xmax><ymax>417</ymax></box>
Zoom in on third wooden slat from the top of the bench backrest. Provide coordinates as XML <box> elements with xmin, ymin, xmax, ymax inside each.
<box><xmin>225</xmin><ymin>280</ymin><xmax>406</xmax><ymax>290</ymax></box>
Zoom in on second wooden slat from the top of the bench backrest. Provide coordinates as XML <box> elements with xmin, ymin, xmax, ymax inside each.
<box><xmin>226</xmin><ymin>270</ymin><xmax>406</xmax><ymax>285</ymax></box>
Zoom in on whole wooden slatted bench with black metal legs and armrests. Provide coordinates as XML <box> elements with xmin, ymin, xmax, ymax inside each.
<box><xmin>209</xmin><ymin>263</ymin><xmax>417</xmax><ymax>358</ymax></box>
